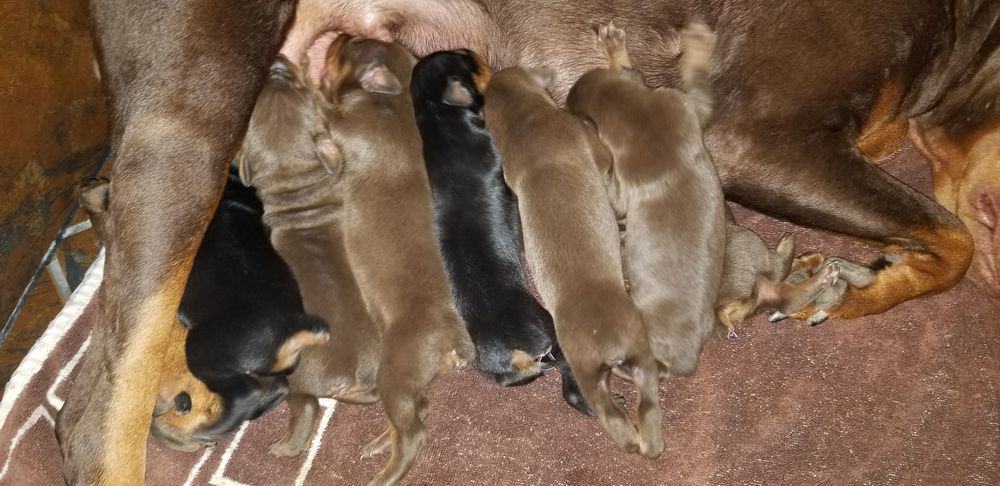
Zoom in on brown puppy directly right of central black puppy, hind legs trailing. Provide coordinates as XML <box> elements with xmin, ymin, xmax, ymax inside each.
<box><xmin>484</xmin><ymin>68</ymin><xmax>663</xmax><ymax>457</ymax></box>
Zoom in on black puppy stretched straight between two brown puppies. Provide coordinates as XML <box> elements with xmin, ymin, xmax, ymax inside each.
<box><xmin>410</xmin><ymin>49</ymin><xmax>593</xmax><ymax>415</ymax></box>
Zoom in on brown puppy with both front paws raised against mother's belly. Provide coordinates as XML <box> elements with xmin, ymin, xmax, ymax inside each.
<box><xmin>567</xmin><ymin>24</ymin><xmax>726</xmax><ymax>375</ymax></box>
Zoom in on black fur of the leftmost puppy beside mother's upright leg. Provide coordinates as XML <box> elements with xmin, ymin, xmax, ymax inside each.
<box><xmin>180</xmin><ymin>172</ymin><xmax>328</xmax><ymax>440</ymax></box>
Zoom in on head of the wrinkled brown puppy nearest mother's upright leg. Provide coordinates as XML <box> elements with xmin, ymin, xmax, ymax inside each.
<box><xmin>236</xmin><ymin>56</ymin><xmax>340</xmax><ymax>192</ymax></box>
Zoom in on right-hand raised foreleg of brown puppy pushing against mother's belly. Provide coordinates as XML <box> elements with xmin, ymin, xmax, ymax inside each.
<box><xmin>680</xmin><ymin>20</ymin><xmax>715</xmax><ymax>127</ymax></box>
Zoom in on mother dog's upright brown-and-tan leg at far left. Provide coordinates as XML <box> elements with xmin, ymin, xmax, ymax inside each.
<box><xmin>58</xmin><ymin>0</ymin><xmax>294</xmax><ymax>484</ymax></box>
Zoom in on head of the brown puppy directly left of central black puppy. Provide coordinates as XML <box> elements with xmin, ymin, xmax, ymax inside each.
<box><xmin>320</xmin><ymin>35</ymin><xmax>417</xmax><ymax>103</ymax></box>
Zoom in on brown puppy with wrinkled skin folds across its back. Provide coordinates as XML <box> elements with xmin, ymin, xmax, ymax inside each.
<box><xmin>237</xmin><ymin>56</ymin><xmax>381</xmax><ymax>456</ymax></box>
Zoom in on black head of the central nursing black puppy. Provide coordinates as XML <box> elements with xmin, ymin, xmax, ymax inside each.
<box><xmin>410</xmin><ymin>49</ymin><xmax>490</xmax><ymax>112</ymax></box>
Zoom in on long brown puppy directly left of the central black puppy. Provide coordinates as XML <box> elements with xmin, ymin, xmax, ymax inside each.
<box><xmin>321</xmin><ymin>36</ymin><xmax>474</xmax><ymax>484</ymax></box>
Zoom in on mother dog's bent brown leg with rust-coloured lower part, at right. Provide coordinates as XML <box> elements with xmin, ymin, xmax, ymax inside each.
<box><xmin>713</xmin><ymin>128</ymin><xmax>973</xmax><ymax>318</ymax></box>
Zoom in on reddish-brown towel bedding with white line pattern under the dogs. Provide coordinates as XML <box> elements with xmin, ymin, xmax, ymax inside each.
<box><xmin>0</xmin><ymin>143</ymin><xmax>1000</xmax><ymax>485</ymax></box>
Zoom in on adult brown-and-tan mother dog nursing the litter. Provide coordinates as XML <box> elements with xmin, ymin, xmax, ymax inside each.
<box><xmin>58</xmin><ymin>0</ymin><xmax>1000</xmax><ymax>484</ymax></box>
